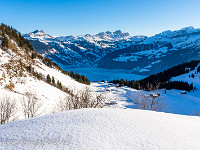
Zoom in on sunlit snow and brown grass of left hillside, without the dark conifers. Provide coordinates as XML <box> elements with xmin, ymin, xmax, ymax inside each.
<box><xmin>0</xmin><ymin>29</ymin><xmax>86</xmax><ymax>120</ymax></box>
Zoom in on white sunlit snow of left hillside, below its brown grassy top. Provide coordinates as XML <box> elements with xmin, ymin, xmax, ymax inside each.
<box><xmin>0</xmin><ymin>44</ymin><xmax>86</xmax><ymax>119</ymax></box>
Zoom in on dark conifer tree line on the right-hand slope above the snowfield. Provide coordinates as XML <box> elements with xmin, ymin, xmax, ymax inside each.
<box><xmin>110</xmin><ymin>60</ymin><xmax>200</xmax><ymax>91</ymax></box>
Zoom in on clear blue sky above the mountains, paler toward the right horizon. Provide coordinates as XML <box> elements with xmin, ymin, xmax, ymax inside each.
<box><xmin>0</xmin><ymin>0</ymin><xmax>200</xmax><ymax>36</ymax></box>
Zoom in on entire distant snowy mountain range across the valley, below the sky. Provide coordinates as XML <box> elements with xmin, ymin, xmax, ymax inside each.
<box><xmin>24</xmin><ymin>27</ymin><xmax>200</xmax><ymax>75</ymax></box>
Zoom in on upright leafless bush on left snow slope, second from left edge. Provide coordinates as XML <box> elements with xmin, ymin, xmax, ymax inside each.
<box><xmin>21</xmin><ymin>92</ymin><xmax>42</xmax><ymax>118</ymax></box>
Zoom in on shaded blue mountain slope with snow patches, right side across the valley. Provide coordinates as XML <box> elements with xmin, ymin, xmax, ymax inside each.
<box><xmin>98</xmin><ymin>27</ymin><xmax>200</xmax><ymax>75</ymax></box>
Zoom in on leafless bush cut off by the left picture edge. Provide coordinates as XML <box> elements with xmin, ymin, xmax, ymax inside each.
<box><xmin>0</xmin><ymin>96</ymin><xmax>17</xmax><ymax>124</ymax></box>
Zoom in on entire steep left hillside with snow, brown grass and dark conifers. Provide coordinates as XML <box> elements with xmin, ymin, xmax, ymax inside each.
<box><xmin>0</xmin><ymin>24</ymin><xmax>86</xmax><ymax>124</ymax></box>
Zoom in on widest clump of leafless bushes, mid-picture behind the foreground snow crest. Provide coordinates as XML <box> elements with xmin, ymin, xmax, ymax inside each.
<box><xmin>57</xmin><ymin>87</ymin><xmax>105</xmax><ymax>111</ymax></box>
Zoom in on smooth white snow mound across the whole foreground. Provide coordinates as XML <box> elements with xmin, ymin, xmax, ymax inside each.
<box><xmin>0</xmin><ymin>109</ymin><xmax>200</xmax><ymax>150</ymax></box>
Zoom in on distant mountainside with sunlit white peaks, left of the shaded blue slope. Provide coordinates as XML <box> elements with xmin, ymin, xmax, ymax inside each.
<box><xmin>24</xmin><ymin>30</ymin><xmax>145</xmax><ymax>65</ymax></box>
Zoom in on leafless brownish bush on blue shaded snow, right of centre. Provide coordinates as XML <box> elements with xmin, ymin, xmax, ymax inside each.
<box><xmin>133</xmin><ymin>92</ymin><xmax>166</xmax><ymax>111</ymax></box>
